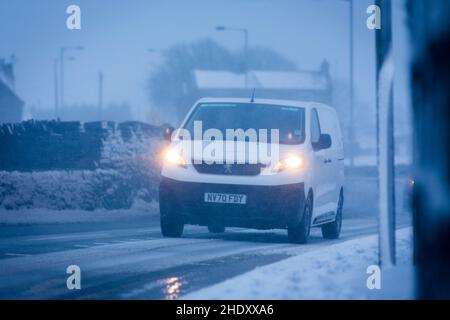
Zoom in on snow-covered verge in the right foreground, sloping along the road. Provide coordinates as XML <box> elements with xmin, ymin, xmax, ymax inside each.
<box><xmin>182</xmin><ymin>228</ymin><xmax>412</xmax><ymax>300</ymax></box>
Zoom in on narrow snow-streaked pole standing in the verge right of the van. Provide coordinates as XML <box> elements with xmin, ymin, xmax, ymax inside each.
<box><xmin>376</xmin><ymin>0</ymin><xmax>395</xmax><ymax>267</ymax></box>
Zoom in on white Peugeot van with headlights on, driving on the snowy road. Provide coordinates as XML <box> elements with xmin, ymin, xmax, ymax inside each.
<box><xmin>159</xmin><ymin>98</ymin><xmax>344</xmax><ymax>243</ymax></box>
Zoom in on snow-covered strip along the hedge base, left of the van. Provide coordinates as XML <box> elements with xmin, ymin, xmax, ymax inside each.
<box><xmin>0</xmin><ymin>201</ymin><xmax>159</xmax><ymax>224</ymax></box>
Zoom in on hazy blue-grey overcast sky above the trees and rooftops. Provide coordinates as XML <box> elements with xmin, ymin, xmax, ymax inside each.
<box><xmin>0</xmin><ymin>0</ymin><xmax>404</xmax><ymax>118</ymax></box>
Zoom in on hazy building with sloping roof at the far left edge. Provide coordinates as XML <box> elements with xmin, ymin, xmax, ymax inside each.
<box><xmin>0</xmin><ymin>59</ymin><xmax>24</xmax><ymax>123</ymax></box>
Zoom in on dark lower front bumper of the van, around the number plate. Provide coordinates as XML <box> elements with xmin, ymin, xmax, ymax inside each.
<box><xmin>159</xmin><ymin>177</ymin><xmax>305</xmax><ymax>229</ymax></box>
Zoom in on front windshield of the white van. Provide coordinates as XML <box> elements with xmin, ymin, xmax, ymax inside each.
<box><xmin>184</xmin><ymin>103</ymin><xmax>305</xmax><ymax>145</ymax></box>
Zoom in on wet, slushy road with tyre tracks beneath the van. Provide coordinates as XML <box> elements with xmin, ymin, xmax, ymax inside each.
<box><xmin>0</xmin><ymin>175</ymin><xmax>410</xmax><ymax>299</ymax></box>
